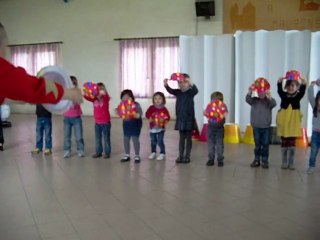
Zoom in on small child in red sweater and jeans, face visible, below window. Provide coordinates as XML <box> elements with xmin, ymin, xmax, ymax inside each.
<box><xmin>146</xmin><ymin>92</ymin><xmax>170</xmax><ymax>161</ymax></box>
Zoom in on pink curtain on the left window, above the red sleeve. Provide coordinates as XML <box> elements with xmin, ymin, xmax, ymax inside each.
<box><xmin>10</xmin><ymin>43</ymin><xmax>60</xmax><ymax>75</ymax></box>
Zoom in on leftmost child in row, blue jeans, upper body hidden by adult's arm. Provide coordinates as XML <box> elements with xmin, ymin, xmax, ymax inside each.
<box><xmin>33</xmin><ymin>104</ymin><xmax>52</xmax><ymax>155</ymax></box>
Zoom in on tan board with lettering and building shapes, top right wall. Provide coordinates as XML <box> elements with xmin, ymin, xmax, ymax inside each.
<box><xmin>223</xmin><ymin>0</ymin><xmax>320</xmax><ymax>33</ymax></box>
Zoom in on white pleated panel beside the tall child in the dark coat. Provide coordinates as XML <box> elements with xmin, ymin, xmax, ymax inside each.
<box><xmin>180</xmin><ymin>35</ymin><xmax>234</xmax><ymax>130</ymax></box>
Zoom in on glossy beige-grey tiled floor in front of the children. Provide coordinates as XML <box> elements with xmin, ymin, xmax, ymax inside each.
<box><xmin>0</xmin><ymin>115</ymin><xmax>320</xmax><ymax>240</ymax></box>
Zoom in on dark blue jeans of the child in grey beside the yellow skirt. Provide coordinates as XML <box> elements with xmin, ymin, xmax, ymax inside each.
<box><xmin>253</xmin><ymin>127</ymin><xmax>270</xmax><ymax>162</ymax></box>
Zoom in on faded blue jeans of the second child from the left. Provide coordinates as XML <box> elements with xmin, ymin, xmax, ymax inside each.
<box><xmin>63</xmin><ymin>117</ymin><xmax>84</xmax><ymax>151</ymax></box>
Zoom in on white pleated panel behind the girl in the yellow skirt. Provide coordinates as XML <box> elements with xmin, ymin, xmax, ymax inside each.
<box><xmin>235</xmin><ymin>30</ymin><xmax>310</xmax><ymax>131</ymax></box>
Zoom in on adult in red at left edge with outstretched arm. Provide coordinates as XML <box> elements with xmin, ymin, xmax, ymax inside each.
<box><xmin>0</xmin><ymin>23</ymin><xmax>82</xmax><ymax>150</ymax></box>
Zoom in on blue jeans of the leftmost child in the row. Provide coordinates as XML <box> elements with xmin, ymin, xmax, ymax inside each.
<box><xmin>36</xmin><ymin>117</ymin><xmax>52</xmax><ymax>150</ymax></box>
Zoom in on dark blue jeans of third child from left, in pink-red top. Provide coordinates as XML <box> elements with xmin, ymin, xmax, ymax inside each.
<box><xmin>95</xmin><ymin>123</ymin><xmax>111</xmax><ymax>154</ymax></box>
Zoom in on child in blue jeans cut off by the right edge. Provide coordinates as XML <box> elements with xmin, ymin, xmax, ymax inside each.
<box><xmin>307</xmin><ymin>79</ymin><xmax>320</xmax><ymax>174</ymax></box>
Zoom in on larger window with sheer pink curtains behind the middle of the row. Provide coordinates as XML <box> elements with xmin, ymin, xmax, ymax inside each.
<box><xmin>120</xmin><ymin>38</ymin><xmax>179</xmax><ymax>97</ymax></box>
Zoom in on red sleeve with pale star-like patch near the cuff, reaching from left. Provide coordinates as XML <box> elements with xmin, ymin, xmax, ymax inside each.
<box><xmin>0</xmin><ymin>58</ymin><xmax>64</xmax><ymax>104</ymax></box>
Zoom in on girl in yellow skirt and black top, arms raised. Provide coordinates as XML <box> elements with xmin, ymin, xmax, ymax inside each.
<box><xmin>277</xmin><ymin>77</ymin><xmax>306</xmax><ymax>170</ymax></box>
